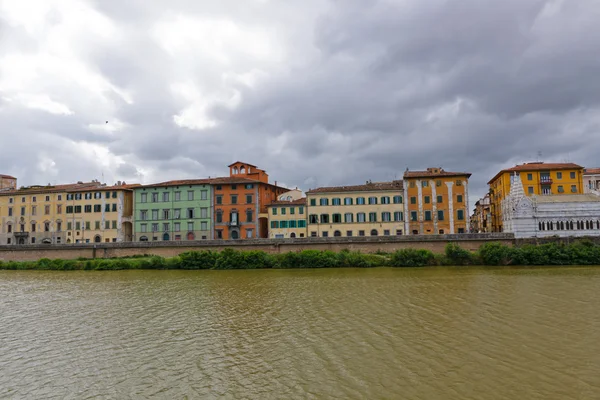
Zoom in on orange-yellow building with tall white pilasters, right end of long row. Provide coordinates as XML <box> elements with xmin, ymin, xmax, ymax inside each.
<box><xmin>404</xmin><ymin>168</ymin><xmax>471</xmax><ymax>235</ymax></box>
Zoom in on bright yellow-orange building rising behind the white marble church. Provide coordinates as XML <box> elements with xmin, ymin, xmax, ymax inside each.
<box><xmin>488</xmin><ymin>162</ymin><xmax>585</xmax><ymax>232</ymax></box>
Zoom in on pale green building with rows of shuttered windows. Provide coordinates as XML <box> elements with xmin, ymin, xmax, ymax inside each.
<box><xmin>134</xmin><ymin>179</ymin><xmax>213</xmax><ymax>242</ymax></box>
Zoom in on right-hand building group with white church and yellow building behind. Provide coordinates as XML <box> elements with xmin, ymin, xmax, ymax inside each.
<box><xmin>471</xmin><ymin>162</ymin><xmax>600</xmax><ymax>238</ymax></box>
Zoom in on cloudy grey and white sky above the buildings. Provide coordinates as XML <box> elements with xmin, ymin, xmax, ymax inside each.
<box><xmin>0</xmin><ymin>0</ymin><xmax>600</xmax><ymax>206</ymax></box>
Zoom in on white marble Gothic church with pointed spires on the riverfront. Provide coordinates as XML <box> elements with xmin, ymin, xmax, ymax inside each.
<box><xmin>502</xmin><ymin>175</ymin><xmax>600</xmax><ymax>238</ymax></box>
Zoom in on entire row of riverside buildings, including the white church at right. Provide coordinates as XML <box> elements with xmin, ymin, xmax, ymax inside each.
<box><xmin>0</xmin><ymin>161</ymin><xmax>600</xmax><ymax>245</ymax></box>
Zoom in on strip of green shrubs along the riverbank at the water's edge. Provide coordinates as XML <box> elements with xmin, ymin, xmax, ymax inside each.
<box><xmin>0</xmin><ymin>240</ymin><xmax>600</xmax><ymax>271</ymax></box>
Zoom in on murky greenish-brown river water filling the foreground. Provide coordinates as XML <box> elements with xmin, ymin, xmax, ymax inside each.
<box><xmin>0</xmin><ymin>267</ymin><xmax>600</xmax><ymax>400</ymax></box>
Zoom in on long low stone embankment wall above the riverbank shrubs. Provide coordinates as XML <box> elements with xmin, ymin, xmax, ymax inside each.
<box><xmin>0</xmin><ymin>233</ymin><xmax>515</xmax><ymax>261</ymax></box>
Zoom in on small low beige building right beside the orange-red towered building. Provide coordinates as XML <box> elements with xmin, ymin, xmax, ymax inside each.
<box><xmin>267</xmin><ymin>198</ymin><xmax>307</xmax><ymax>239</ymax></box>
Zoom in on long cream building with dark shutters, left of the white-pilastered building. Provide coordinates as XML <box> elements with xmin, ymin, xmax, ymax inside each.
<box><xmin>306</xmin><ymin>181</ymin><xmax>405</xmax><ymax>237</ymax></box>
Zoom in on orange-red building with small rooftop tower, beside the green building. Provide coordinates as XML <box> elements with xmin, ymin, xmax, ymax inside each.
<box><xmin>211</xmin><ymin>161</ymin><xmax>288</xmax><ymax>240</ymax></box>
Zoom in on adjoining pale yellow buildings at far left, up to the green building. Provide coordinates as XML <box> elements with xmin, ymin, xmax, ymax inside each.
<box><xmin>0</xmin><ymin>181</ymin><xmax>132</xmax><ymax>245</ymax></box>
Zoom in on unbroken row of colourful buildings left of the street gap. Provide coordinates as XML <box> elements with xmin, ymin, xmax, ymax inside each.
<box><xmin>0</xmin><ymin>162</ymin><xmax>471</xmax><ymax>245</ymax></box>
